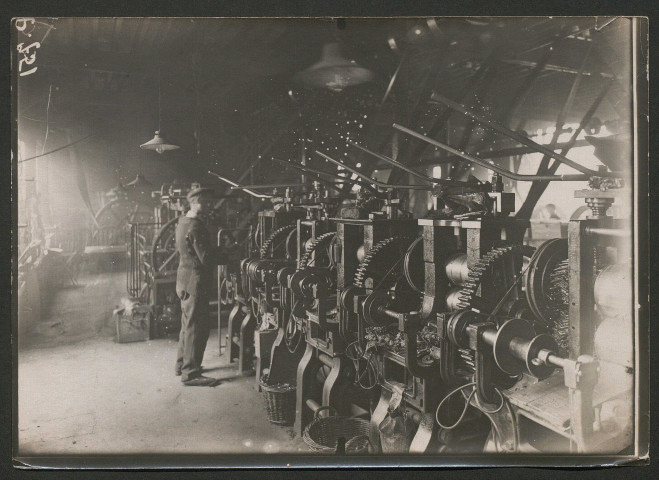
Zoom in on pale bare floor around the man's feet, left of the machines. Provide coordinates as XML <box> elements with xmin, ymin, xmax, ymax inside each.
<box><xmin>18</xmin><ymin>273</ymin><xmax>308</xmax><ymax>456</ymax></box>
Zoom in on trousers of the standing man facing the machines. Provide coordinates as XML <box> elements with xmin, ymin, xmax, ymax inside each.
<box><xmin>176</xmin><ymin>289</ymin><xmax>210</xmax><ymax>382</ymax></box>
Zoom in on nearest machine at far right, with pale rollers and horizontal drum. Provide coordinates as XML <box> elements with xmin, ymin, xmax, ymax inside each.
<box><xmin>438</xmin><ymin>184</ymin><xmax>633</xmax><ymax>453</ymax></box>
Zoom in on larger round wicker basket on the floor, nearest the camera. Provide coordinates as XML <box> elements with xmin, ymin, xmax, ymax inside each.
<box><xmin>302</xmin><ymin>406</ymin><xmax>370</xmax><ymax>455</ymax></box>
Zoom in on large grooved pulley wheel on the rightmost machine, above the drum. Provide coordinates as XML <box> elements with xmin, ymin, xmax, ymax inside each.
<box><xmin>524</xmin><ymin>238</ymin><xmax>567</xmax><ymax>324</ymax></box>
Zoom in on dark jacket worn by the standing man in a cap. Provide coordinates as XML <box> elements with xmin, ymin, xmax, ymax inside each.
<box><xmin>176</xmin><ymin>216</ymin><xmax>227</xmax><ymax>298</ymax></box>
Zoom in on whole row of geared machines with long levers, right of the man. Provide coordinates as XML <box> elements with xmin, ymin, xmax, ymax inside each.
<box><xmin>211</xmin><ymin>112</ymin><xmax>634</xmax><ymax>453</ymax></box>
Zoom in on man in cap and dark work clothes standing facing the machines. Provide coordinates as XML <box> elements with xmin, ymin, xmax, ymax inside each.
<box><xmin>176</xmin><ymin>188</ymin><xmax>235</xmax><ymax>387</ymax></box>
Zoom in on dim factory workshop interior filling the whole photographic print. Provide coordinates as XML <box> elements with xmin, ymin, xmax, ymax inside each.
<box><xmin>14</xmin><ymin>17</ymin><xmax>640</xmax><ymax>463</ymax></box>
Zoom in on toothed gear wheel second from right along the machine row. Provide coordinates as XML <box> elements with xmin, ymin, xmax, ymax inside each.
<box><xmin>353</xmin><ymin>237</ymin><xmax>416</xmax><ymax>289</ymax></box>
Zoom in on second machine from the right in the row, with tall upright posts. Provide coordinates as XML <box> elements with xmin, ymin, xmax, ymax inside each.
<box><xmin>336</xmin><ymin>144</ymin><xmax>526</xmax><ymax>453</ymax></box>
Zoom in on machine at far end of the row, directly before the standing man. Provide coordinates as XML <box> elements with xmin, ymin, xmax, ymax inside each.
<box><xmin>211</xmin><ymin>172</ymin><xmax>336</xmax><ymax>378</ymax></box>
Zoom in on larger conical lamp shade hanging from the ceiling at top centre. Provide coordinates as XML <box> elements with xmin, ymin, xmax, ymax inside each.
<box><xmin>293</xmin><ymin>43</ymin><xmax>373</xmax><ymax>92</ymax></box>
